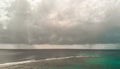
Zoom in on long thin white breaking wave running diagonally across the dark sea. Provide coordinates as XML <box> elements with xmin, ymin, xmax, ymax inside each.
<box><xmin>0</xmin><ymin>56</ymin><xmax>99</xmax><ymax>67</ymax></box>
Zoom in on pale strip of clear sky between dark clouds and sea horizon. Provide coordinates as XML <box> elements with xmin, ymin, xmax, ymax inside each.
<box><xmin>0</xmin><ymin>44</ymin><xmax>120</xmax><ymax>50</ymax></box>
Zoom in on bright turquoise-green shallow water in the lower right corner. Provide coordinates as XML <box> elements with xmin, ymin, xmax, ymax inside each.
<box><xmin>40</xmin><ymin>57</ymin><xmax>120</xmax><ymax>69</ymax></box>
